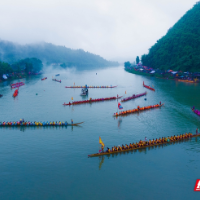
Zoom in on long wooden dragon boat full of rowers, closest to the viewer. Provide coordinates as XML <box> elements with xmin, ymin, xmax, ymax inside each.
<box><xmin>88</xmin><ymin>133</ymin><xmax>200</xmax><ymax>157</ymax></box>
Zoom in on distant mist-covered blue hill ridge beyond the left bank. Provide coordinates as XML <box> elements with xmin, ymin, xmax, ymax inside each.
<box><xmin>0</xmin><ymin>40</ymin><xmax>118</xmax><ymax>69</ymax></box>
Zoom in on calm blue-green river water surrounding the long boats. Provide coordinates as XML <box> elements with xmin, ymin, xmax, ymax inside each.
<box><xmin>0</xmin><ymin>66</ymin><xmax>200</xmax><ymax>200</ymax></box>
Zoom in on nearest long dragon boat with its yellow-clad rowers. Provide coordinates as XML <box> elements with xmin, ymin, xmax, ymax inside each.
<box><xmin>88</xmin><ymin>133</ymin><xmax>200</xmax><ymax>157</ymax></box>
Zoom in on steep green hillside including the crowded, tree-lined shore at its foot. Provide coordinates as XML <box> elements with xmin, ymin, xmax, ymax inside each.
<box><xmin>124</xmin><ymin>1</ymin><xmax>200</xmax><ymax>83</ymax></box>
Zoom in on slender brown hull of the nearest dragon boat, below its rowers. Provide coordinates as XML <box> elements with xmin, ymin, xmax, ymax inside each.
<box><xmin>88</xmin><ymin>133</ymin><xmax>200</xmax><ymax>157</ymax></box>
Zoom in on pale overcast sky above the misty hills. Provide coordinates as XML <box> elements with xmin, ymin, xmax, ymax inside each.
<box><xmin>0</xmin><ymin>0</ymin><xmax>197</xmax><ymax>62</ymax></box>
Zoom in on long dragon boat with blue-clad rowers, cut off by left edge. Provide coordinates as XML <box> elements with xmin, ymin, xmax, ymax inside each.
<box><xmin>0</xmin><ymin>121</ymin><xmax>83</xmax><ymax>126</ymax></box>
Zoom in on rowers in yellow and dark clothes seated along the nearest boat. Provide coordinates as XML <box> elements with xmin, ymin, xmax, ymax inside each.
<box><xmin>102</xmin><ymin>133</ymin><xmax>192</xmax><ymax>153</ymax></box>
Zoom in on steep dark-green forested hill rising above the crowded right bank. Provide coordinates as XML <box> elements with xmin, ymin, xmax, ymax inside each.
<box><xmin>141</xmin><ymin>2</ymin><xmax>200</xmax><ymax>72</ymax></box>
